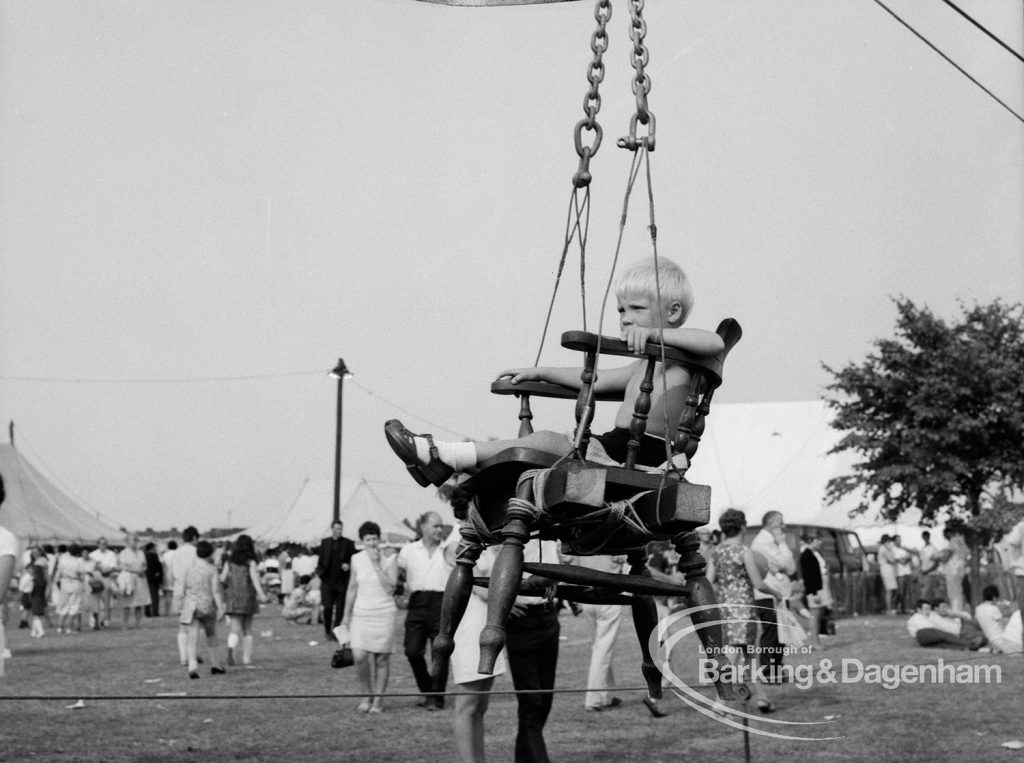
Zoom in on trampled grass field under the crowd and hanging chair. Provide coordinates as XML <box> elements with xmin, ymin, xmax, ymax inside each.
<box><xmin>0</xmin><ymin>605</ymin><xmax>1024</xmax><ymax>763</ymax></box>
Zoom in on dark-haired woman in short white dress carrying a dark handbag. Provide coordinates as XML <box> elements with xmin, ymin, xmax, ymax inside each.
<box><xmin>339</xmin><ymin>522</ymin><xmax>398</xmax><ymax>713</ymax></box>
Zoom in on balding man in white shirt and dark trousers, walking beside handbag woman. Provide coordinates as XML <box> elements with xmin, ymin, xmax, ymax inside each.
<box><xmin>398</xmin><ymin>511</ymin><xmax>459</xmax><ymax>711</ymax></box>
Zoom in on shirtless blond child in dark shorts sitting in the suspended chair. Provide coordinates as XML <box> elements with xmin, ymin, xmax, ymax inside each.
<box><xmin>384</xmin><ymin>257</ymin><xmax>725</xmax><ymax>488</ymax></box>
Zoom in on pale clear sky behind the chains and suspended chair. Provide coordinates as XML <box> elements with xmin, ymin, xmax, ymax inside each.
<box><xmin>0</xmin><ymin>0</ymin><xmax>1024</xmax><ymax>529</ymax></box>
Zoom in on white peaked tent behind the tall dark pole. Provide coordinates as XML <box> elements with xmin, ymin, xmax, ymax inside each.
<box><xmin>239</xmin><ymin>479</ymin><xmax>452</xmax><ymax>546</ymax></box>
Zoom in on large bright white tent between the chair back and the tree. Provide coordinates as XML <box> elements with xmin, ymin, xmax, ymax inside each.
<box><xmin>686</xmin><ymin>400</ymin><xmax>933</xmax><ymax>543</ymax></box>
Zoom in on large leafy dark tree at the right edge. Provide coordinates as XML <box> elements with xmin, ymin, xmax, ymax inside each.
<box><xmin>825</xmin><ymin>298</ymin><xmax>1024</xmax><ymax>598</ymax></box>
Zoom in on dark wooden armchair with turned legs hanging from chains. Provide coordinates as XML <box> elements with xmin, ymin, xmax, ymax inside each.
<box><xmin>433</xmin><ymin>319</ymin><xmax>742</xmax><ymax>698</ymax></box>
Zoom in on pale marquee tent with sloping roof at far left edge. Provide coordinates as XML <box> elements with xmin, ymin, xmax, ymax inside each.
<box><xmin>0</xmin><ymin>443</ymin><xmax>122</xmax><ymax>543</ymax></box>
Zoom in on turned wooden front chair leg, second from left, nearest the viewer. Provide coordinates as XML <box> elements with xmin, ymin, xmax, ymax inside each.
<box><xmin>477</xmin><ymin>479</ymin><xmax>537</xmax><ymax>675</ymax></box>
